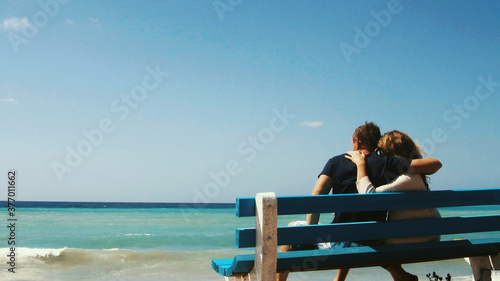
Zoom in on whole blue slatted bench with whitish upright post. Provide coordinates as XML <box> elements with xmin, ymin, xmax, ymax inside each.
<box><xmin>212</xmin><ymin>189</ymin><xmax>500</xmax><ymax>281</ymax></box>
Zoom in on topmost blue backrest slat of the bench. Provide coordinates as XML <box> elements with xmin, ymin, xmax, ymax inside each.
<box><xmin>236</xmin><ymin>189</ymin><xmax>500</xmax><ymax>217</ymax></box>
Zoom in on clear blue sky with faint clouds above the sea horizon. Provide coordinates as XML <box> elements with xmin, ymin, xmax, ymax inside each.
<box><xmin>0</xmin><ymin>0</ymin><xmax>500</xmax><ymax>203</ymax></box>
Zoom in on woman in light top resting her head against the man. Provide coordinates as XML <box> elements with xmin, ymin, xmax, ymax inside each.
<box><xmin>346</xmin><ymin>131</ymin><xmax>440</xmax><ymax>281</ymax></box>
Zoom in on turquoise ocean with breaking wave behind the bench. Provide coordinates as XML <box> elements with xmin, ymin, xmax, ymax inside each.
<box><xmin>0</xmin><ymin>202</ymin><xmax>500</xmax><ymax>281</ymax></box>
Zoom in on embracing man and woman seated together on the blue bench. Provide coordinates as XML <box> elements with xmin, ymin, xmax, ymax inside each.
<box><xmin>277</xmin><ymin>122</ymin><xmax>442</xmax><ymax>281</ymax></box>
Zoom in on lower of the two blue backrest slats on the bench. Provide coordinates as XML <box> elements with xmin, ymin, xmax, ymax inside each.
<box><xmin>236</xmin><ymin>215</ymin><xmax>500</xmax><ymax>248</ymax></box>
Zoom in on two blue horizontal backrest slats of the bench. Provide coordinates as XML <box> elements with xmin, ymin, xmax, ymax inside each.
<box><xmin>236</xmin><ymin>189</ymin><xmax>500</xmax><ymax>248</ymax></box>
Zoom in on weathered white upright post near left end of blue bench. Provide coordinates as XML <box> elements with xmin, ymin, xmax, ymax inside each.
<box><xmin>249</xmin><ymin>192</ymin><xmax>278</xmax><ymax>281</ymax></box>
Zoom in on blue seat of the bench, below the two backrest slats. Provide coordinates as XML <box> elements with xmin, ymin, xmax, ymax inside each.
<box><xmin>216</xmin><ymin>238</ymin><xmax>500</xmax><ymax>276</ymax></box>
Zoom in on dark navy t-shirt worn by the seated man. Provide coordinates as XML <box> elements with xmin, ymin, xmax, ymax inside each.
<box><xmin>321</xmin><ymin>153</ymin><xmax>411</xmax><ymax>222</ymax></box>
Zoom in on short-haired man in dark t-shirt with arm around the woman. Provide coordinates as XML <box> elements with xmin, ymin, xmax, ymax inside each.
<box><xmin>277</xmin><ymin>122</ymin><xmax>442</xmax><ymax>281</ymax></box>
